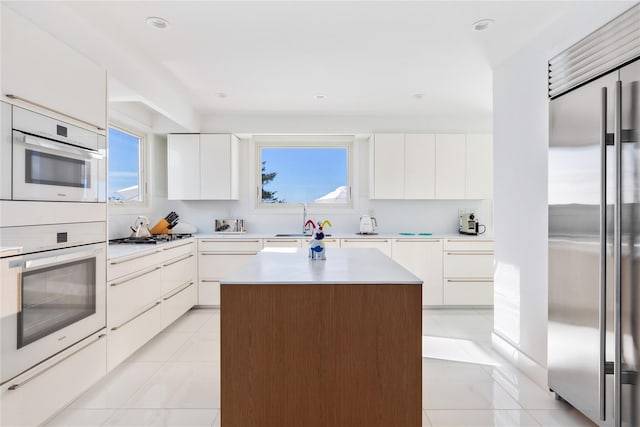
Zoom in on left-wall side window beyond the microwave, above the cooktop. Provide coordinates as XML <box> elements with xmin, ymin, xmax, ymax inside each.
<box><xmin>107</xmin><ymin>126</ymin><xmax>145</xmax><ymax>203</ymax></box>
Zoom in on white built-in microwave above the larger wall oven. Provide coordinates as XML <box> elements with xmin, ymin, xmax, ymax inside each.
<box><xmin>0</xmin><ymin>105</ymin><xmax>106</xmax><ymax>203</ymax></box>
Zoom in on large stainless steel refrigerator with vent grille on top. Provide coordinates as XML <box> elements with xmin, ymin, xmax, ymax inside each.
<box><xmin>548</xmin><ymin>6</ymin><xmax>640</xmax><ymax>426</ymax></box>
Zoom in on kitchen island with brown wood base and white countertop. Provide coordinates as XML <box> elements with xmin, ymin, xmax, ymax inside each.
<box><xmin>220</xmin><ymin>248</ymin><xmax>422</xmax><ymax>427</ymax></box>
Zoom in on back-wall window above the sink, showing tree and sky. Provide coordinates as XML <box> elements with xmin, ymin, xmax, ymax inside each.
<box><xmin>256</xmin><ymin>137</ymin><xmax>352</xmax><ymax>206</ymax></box>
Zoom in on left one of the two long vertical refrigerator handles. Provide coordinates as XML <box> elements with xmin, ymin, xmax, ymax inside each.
<box><xmin>598</xmin><ymin>87</ymin><xmax>607</xmax><ymax>421</ymax></box>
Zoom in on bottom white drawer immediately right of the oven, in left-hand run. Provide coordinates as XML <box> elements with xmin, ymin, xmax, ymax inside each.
<box><xmin>107</xmin><ymin>301</ymin><xmax>162</xmax><ymax>371</ymax></box>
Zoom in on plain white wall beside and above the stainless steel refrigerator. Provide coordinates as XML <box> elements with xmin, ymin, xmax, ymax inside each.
<box><xmin>493</xmin><ymin>2</ymin><xmax>633</xmax><ymax>385</ymax></box>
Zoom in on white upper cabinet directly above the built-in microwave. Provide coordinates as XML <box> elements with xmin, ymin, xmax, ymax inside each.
<box><xmin>0</xmin><ymin>6</ymin><xmax>107</xmax><ymax>129</ymax></box>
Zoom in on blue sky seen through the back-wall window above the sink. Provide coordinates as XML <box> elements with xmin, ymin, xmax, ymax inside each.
<box><xmin>261</xmin><ymin>147</ymin><xmax>348</xmax><ymax>203</ymax></box>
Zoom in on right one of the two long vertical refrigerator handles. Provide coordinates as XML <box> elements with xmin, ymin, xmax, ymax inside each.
<box><xmin>613</xmin><ymin>80</ymin><xmax>622</xmax><ymax>427</ymax></box>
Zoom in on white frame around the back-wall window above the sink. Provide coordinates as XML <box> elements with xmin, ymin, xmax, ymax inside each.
<box><xmin>251</xmin><ymin>135</ymin><xmax>357</xmax><ymax>213</ymax></box>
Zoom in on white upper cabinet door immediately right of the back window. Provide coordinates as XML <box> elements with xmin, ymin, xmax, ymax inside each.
<box><xmin>371</xmin><ymin>134</ymin><xmax>404</xmax><ymax>199</ymax></box>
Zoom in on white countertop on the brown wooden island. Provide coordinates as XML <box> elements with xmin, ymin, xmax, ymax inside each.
<box><xmin>220</xmin><ymin>248</ymin><xmax>422</xmax><ymax>285</ymax></box>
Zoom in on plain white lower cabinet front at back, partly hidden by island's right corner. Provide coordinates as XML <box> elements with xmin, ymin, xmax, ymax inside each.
<box><xmin>392</xmin><ymin>239</ymin><xmax>443</xmax><ymax>305</ymax></box>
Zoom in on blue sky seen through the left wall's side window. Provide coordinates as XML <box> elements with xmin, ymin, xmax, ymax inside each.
<box><xmin>107</xmin><ymin>128</ymin><xmax>140</xmax><ymax>198</ymax></box>
